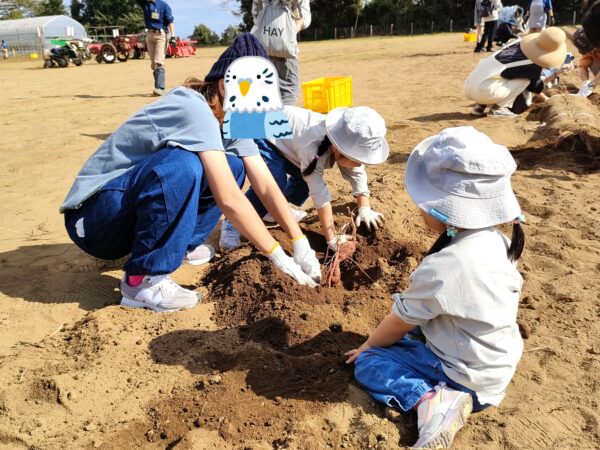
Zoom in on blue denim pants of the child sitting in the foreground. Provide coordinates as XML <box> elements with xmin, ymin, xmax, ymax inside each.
<box><xmin>354</xmin><ymin>334</ymin><xmax>489</xmax><ymax>411</ymax></box>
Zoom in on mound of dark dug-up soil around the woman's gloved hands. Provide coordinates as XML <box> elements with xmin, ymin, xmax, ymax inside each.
<box><xmin>205</xmin><ymin>224</ymin><xmax>423</xmax><ymax>349</ymax></box>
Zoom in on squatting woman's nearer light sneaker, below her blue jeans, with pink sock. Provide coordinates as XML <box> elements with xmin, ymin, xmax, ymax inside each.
<box><xmin>121</xmin><ymin>275</ymin><xmax>202</xmax><ymax>312</ymax></box>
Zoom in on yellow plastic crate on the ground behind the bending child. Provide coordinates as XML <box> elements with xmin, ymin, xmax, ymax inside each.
<box><xmin>302</xmin><ymin>77</ymin><xmax>352</xmax><ymax>113</ymax></box>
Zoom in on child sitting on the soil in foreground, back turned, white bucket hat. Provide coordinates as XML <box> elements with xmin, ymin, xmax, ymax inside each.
<box><xmin>346</xmin><ymin>127</ymin><xmax>525</xmax><ymax>448</ymax></box>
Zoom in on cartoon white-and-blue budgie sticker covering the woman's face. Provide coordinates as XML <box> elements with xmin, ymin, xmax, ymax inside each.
<box><xmin>223</xmin><ymin>56</ymin><xmax>293</xmax><ymax>139</ymax></box>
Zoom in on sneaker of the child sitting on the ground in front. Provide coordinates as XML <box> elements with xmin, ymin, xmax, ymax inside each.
<box><xmin>412</xmin><ymin>382</ymin><xmax>473</xmax><ymax>448</ymax></box>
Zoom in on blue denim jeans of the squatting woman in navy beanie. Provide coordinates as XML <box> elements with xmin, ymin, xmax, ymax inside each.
<box><xmin>65</xmin><ymin>147</ymin><xmax>246</xmax><ymax>275</ymax></box>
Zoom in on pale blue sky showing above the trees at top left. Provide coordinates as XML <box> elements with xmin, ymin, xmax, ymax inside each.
<box><xmin>64</xmin><ymin>0</ymin><xmax>240</xmax><ymax>37</ymax></box>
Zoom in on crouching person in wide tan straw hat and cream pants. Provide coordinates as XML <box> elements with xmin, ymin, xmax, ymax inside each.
<box><xmin>464</xmin><ymin>27</ymin><xmax>567</xmax><ymax>117</ymax></box>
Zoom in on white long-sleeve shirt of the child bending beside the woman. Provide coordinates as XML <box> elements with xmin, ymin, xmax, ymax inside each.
<box><xmin>269</xmin><ymin>106</ymin><xmax>370</xmax><ymax>208</ymax></box>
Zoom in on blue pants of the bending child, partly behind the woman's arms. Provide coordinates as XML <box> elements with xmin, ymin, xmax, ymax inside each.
<box><xmin>246</xmin><ymin>139</ymin><xmax>308</xmax><ymax>217</ymax></box>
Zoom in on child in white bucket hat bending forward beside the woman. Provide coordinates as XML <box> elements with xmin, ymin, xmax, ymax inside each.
<box><xmin>220</xmin><ymin>106</ymin><xmax>389</xmax><ymax>250</ymax></box>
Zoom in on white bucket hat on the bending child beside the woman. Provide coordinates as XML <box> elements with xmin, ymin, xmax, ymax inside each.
<box><xmin>325</xmin><ymin>106</ymin><xmax>390</xmax><ymax>164</ymax></box>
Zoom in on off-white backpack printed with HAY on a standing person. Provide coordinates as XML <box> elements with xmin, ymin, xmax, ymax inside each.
<box><xmin>252</xmin><ymin>0</ymin><xmax>298</xmax><ymax>58</ymax></box>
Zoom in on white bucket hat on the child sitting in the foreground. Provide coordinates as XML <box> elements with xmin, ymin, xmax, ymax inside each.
<box><xmin>405</xmin><ymin>127</ymin><xmax>521</xmax><ymax>229</ymax></box>
